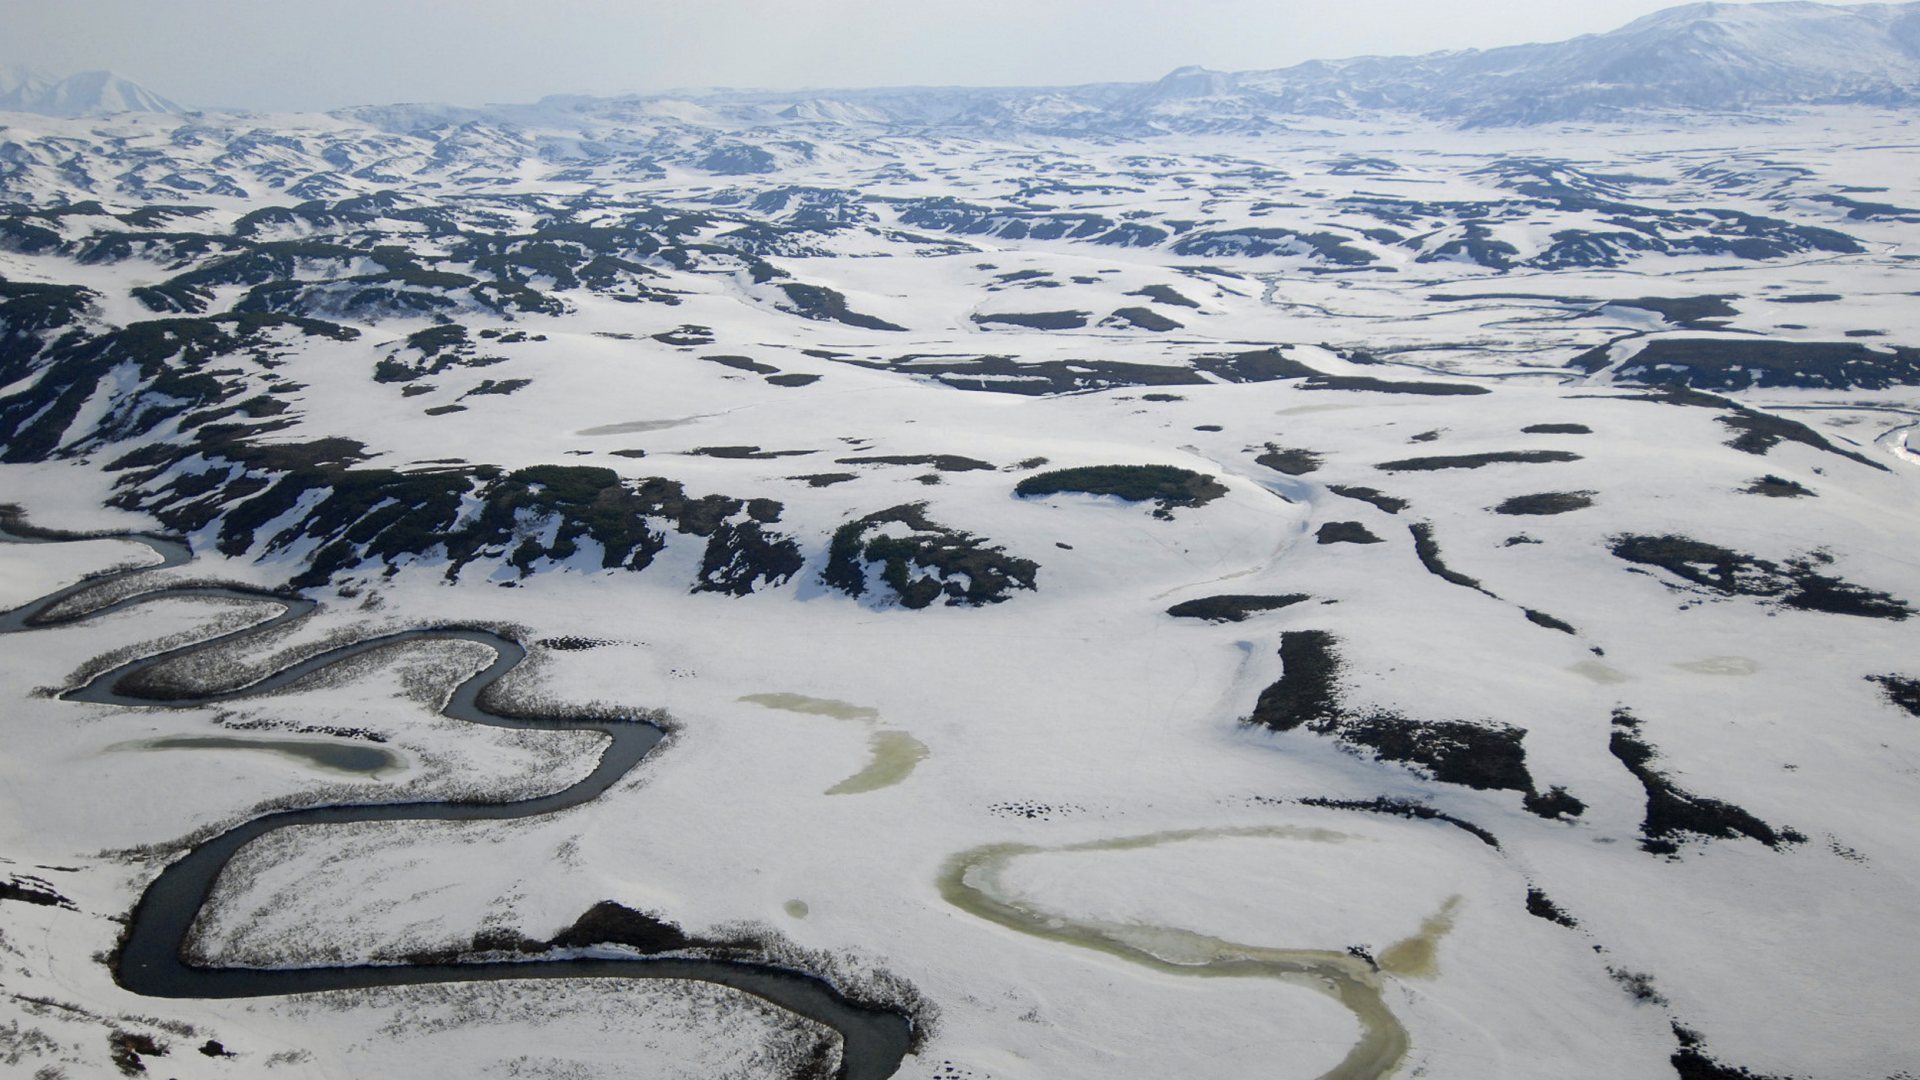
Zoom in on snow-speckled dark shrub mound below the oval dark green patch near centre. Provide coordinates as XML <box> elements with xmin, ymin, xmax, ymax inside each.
<box><xmin>820</xmin><ymin>503</ymin><xmax>1041</xmax><ymax>609</ymax></box>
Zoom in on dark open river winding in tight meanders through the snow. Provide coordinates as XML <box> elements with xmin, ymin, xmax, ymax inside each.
<box><xmin>0</xmin><ymin>525</ymin><xmax>912</xmax><ymax>1080</ymax></box>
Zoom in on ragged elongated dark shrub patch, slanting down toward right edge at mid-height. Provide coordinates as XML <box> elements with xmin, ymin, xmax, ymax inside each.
<box><xmin>1609</xmin><ymin>534</ymin><xmax>1912</xmax><ymax>621</ymax></box>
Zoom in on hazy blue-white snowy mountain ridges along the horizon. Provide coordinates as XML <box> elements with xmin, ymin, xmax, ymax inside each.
<box><xmin>0</xmin><ymin>0</ymin><xmax>1920</xmax><ymax>126</ymax></box>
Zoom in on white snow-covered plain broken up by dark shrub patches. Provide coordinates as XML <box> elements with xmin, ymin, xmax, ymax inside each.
<box><xmin>0</xmin><ymin>96</ymin><xmax>1920</xmax><ymax>1080</ymax></box>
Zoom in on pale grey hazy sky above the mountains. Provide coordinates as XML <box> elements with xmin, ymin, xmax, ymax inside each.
<box><xmin>0</xmin><ymin>0</ymin><xmax>1858</xmax><ymax>110</ymax></box>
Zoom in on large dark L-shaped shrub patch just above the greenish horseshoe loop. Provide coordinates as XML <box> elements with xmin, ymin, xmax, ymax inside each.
<box><xmin>1244</xmin><ymin>630</ymin><xmax>1559</xmax><ymax>794</ymax></box>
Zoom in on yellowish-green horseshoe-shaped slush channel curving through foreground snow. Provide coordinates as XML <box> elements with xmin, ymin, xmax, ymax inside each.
<box><xmin>939</xmin><ymin>826</ymin><xmax>1413</xmax><ymax>1080</ymax></box>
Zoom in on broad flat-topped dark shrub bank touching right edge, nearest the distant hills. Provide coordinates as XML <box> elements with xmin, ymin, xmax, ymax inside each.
<box><xmin>1615</xmin><ymin>338</ymin><xmax>1920</xmax><ymax>390</ymax></box>
